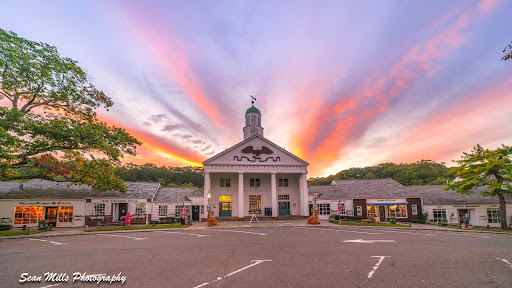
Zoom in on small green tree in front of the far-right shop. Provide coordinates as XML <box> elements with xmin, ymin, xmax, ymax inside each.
<box><xmin>445</xmin><ymin>145</ymin><xmax>512</xmax><ymax>229</ymax></box>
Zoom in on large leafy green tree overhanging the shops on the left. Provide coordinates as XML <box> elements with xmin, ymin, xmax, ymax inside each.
<box><xmin>0</xmin><ymin>29</ymin><xmax>141</xmax><ymax>191</ymax></box>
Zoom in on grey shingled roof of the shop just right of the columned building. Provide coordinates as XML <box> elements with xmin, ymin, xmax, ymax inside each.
<box><xmin>308</xmin><ymin>179</ymin><xmax>412</xmax><ymax>200</ymax></box>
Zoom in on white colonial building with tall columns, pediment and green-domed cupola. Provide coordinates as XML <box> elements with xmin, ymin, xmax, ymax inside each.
<box><xmin>203</xmin><ymin>106</ymin><xmax>309</xmax><ymax>220</ymax></box>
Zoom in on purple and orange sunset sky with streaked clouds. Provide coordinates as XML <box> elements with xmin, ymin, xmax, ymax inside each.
<box><xmin>0</xmin><ymin>0</ymin><xmax>512</xmax><ymax>177</ymax></box>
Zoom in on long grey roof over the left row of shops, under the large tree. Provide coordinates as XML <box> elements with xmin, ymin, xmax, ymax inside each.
<box><xmin>0</xmin><ymin>179</ymin><xmax>160</xmax><ymax>199</ymax></box>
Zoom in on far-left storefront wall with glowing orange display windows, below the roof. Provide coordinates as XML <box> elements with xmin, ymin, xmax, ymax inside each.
<box><xmin>0</xmin><ymin>199</ymin><xmax>85</xmax><ymax>227</ymax></box>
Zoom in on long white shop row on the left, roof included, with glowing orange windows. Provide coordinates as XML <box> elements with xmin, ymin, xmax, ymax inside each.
<box><xmin>0</xmin><ymin>179</ymin><xmax>160</xmax><ymax>227</ymax></box>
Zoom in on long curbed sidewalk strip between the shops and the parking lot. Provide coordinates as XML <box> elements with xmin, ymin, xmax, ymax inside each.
<box><xmin>0</xmin><ymin>219</ymin><xmax>512</xmax><ymax>241</ymax></box>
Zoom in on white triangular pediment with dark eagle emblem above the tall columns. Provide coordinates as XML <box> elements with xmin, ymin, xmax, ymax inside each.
<box><xmin>203</xmin><ymin>135</ymin><xmax>309</xmax><ymax>166</ymax></box>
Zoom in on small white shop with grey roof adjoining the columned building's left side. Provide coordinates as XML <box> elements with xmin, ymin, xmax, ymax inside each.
<box><xmin>151</xmin><ymin>187</ymin><xmax>206</xmax><ymax>221</ymax></box>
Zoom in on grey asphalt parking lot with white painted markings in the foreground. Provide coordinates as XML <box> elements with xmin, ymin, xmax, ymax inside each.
<box><xmin>0</xmin><ymin>226</ymin><xmax>512</xmax><ymax>287</ymax></box>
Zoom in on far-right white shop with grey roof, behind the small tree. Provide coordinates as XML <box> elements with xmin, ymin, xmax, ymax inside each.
<box><xmin>414</xmin><ymin>185</ymin><xmax>512</xmax><ymax>227</ymax></box>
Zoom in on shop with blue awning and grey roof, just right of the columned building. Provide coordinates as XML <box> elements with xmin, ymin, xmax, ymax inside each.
<box><xmin>308</xmin><ymin>179</ymin><xmax>422</xmax><ymax>221</ymax></box>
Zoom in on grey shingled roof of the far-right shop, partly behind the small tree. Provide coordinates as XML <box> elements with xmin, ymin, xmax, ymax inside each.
<box><xmin>407</xmin><ymin>185</ymin><xmax>512</xmax><ymax>205</ymax></box>
